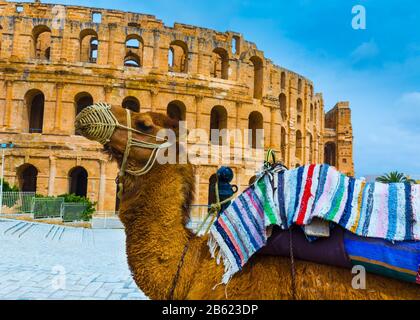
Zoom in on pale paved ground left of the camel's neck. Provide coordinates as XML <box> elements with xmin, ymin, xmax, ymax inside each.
<box><xmin>0</xmin><ymin>219</ymin><xmax>147</xmax><ymax>300</ymax></box>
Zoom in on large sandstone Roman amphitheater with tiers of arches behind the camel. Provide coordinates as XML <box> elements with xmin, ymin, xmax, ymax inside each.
<box><xmin>0</xmin><ymin>0</ymin><xmax>354</xmax><ymax>218</ymax></box>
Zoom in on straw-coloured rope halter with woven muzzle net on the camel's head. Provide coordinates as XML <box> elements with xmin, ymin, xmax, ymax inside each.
<box><xmin>75</xmin><ymin>102</ymin><xmax>172</xmax><ymax>198</ymax></box>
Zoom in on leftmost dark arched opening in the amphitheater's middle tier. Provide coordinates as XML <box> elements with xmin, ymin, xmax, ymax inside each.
<box><xmin>25</xmin><ymin>90</ymin><xmax>45</xmax><ymax>133</ymax></box>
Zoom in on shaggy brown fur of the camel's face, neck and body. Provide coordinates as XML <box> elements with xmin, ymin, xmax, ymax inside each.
<box><xmin>83</xmin><ymin>107</ymin><xmax>420</xmax><ymax>299</ymax></box>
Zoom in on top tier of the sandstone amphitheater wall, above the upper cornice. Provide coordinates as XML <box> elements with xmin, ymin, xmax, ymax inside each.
<box><xmin>0</xmin><ymin>1</ymin><xmax>322</xmax><ymax>103</ymax></box>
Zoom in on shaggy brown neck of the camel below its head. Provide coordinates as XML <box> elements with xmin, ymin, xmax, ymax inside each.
<box><xmin>120</xmin><ymin>165</ymin><xmax>194</xmax><ymax>299</ymax></box>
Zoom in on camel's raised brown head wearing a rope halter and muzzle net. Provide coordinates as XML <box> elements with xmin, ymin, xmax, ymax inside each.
<box><xmin>75</xmin><ymin>103</ymin><xmax>178</xmax><ymax>175</ymax></box>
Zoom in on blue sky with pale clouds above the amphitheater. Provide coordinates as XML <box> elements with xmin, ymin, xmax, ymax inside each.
<box><xmin>43</xmin><ymin>0</ymin><xmax>420</xmax><ymax>179</ymax></box>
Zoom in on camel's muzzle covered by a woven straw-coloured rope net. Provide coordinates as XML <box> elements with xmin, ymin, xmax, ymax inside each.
<box><xmin>75</xmin><ymin>103</ymin><xmax>119</xmax><ymax>144</ymax></box>
